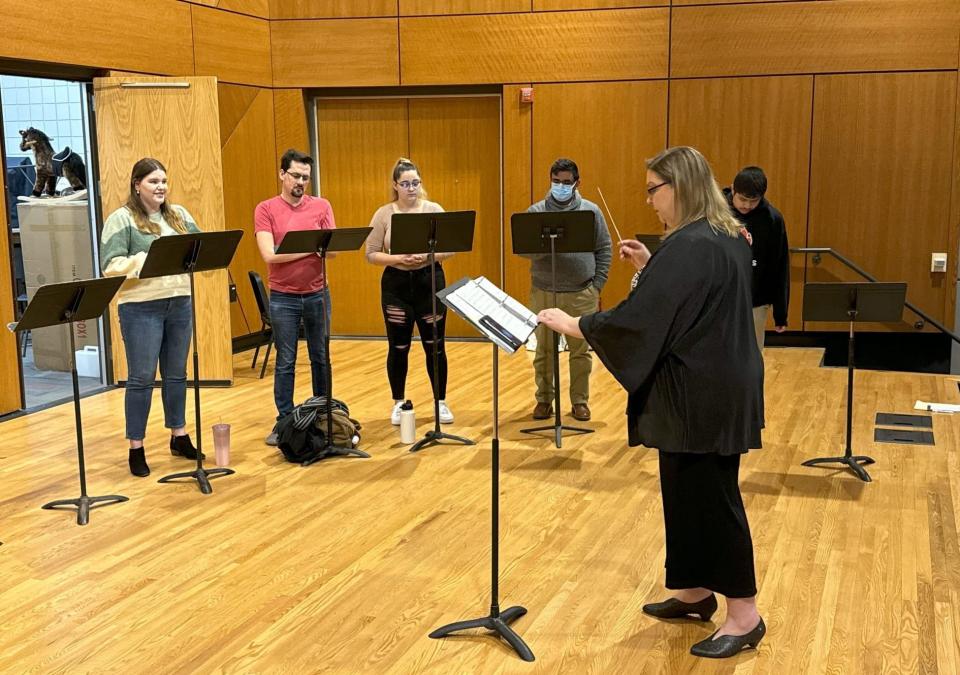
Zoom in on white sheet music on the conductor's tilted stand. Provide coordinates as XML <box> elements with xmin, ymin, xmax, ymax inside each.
<box><xmin>437</xmin><ymin>277</ymin><xmax>539</xmax><ymax>354</ymax></box>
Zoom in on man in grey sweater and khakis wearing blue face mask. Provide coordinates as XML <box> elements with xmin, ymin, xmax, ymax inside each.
<box><xmin>524</xmin><ymin>159</ymin><xmax>612</xmax><ymax>422</ymax></box>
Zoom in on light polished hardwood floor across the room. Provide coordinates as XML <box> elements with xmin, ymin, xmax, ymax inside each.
<box><xmin>0</xmin><ymin>341</ymin><xmax>960</xmax><ymax>675</ymax></box>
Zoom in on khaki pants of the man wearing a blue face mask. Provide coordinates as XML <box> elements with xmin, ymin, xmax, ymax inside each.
<box><xmin>530</xmin><ymin>284</ymin><xmax>600</xmax><ymax>405</ymax></box>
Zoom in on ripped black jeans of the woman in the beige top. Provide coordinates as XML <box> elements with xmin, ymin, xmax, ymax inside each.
<box><xmin>380</xmin><ymin>263</ymin><xmax>447</xmax><ymax>401</ymax></box>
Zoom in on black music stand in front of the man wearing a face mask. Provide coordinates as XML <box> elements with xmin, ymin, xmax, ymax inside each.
<box><xmin>510</xmin><ymin>211</ymin><xmax>596</xmax><ymax>448</ymax></box>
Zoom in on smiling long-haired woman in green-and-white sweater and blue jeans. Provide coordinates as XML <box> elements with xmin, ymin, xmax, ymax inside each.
<box><xmin>100</xmin><ymin>157</ymin><xmax>200</xmax><ymax>476</ymax></box>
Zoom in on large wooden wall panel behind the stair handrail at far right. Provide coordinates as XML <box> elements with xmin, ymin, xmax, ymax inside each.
<box><xmin>806</xmin><ymin>73</ymin><xmax>957</xmax><ymax>330</ymax></box>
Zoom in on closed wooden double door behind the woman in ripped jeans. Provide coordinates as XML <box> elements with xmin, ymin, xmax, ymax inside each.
<box><xmin>317</xmin><ymin>97</ymin><xmax>501</xmax><ymax>337</ymax></box>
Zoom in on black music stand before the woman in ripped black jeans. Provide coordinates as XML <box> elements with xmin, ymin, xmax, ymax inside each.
<box><xmin>390</xmin><ymin>211</ymin><xmax>477</xmax><ymax>452</ymax></box>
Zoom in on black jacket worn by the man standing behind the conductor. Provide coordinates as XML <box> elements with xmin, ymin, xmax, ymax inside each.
<box><xmin>723</xmin><ymin>188</ymin><xmax>790</xmax><ymax>326</ymax></box>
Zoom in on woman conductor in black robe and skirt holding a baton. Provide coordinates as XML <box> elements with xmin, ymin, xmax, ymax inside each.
<box><xmin>539</xmin><ymin>147</ymin><xmax>766</xmax><ymax>658</ymax></box>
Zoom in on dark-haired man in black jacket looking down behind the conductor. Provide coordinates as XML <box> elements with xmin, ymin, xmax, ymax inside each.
<box><xmin>723</xmin><ymin>166</ymin><xmax>790</xmax><ymax>351</ymax></box>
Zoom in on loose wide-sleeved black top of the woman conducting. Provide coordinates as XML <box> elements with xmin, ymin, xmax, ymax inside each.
<box><xmin>580</xmin><ymin>219</ymin><xmax>763</xmax><ymax>455</ymax></box>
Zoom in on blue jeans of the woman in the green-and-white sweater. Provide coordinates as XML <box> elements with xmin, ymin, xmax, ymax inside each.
<box><xmin>119</xmin><ymin>296</ymin><xmax>193</xmax><ymax>441</ymax></box>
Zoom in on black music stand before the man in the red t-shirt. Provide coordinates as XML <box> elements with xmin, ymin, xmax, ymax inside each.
<box><xmin>276</xmin><ymin>227</ymin><xmax>373</xmax><ymax>466</ymax></box>
